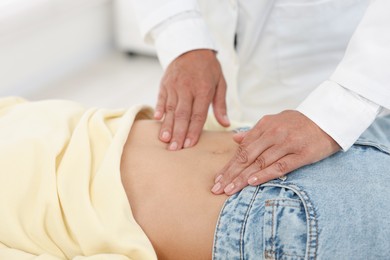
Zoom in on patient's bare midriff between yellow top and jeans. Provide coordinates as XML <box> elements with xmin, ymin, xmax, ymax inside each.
<box><xmin>121</xmin><ymin>120</ymin><xmax>237</xmax><ymax>259</ymax></box>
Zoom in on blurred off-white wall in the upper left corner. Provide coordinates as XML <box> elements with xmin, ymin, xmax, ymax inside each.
<box><xmin>0</xmin><ymin>0</ymin><xmax>114</xmax><ymax>96</ymax></box>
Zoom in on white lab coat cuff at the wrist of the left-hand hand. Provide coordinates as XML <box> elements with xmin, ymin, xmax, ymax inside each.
<box><xmin>155</xmin><ymin>18</ymin><xmax>217</xmax><ymax>69</ymax></box>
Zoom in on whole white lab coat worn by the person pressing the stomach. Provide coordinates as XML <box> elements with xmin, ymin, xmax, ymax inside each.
<box><xmin>135</xmin><ymin>0</ymin><xmax>390</xmax><ymax>150</ymax></box>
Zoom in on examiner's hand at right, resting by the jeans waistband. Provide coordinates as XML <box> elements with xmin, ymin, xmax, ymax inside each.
<box><xmin>212</xmin><ymin>110</ymin><xmax>340</xmax><ymax>195</ymax></box>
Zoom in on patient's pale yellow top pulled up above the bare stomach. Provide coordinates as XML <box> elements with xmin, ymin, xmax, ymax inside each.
<box><xmin>0</xmin><ymin>98</ymin><xmax>156</xmax><ymax>260</ymax></box>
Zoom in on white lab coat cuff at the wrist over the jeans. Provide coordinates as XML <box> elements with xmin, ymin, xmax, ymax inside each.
<box><xmin>297</xmin><ymin>81</ymin><xmax>381</xmax><ymax>151</ymax></box>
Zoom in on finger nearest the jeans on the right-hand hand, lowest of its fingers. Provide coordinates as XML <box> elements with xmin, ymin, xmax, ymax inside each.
<box><xmin>248</xmin><ymin>154</ymin><xmax>306</xmax><ymax>185</ymax></box>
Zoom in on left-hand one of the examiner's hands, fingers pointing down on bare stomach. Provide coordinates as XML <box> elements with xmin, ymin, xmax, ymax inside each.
<box><xmin>154</xmin><ymin>49</ymin><xmax>229</xmax><ymax>151</ymax></box>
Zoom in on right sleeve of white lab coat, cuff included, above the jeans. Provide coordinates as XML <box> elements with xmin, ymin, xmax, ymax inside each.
<box><xmin>297</xmin><ymin>0</ymin><xmax>390</xmax><ymax>150</ymax></box>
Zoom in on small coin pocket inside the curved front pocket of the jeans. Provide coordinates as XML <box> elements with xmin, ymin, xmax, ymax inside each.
<box><xmin>264</xmin><ymin>199</ymin><xmax>307</xmax><ymax>260</ymax></box>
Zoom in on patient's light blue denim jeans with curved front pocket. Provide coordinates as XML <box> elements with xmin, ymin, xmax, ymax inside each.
<box><xmin>213</xmin><ymin>116</ymin><xmax>390</xmax><ymax>260</ymax></box>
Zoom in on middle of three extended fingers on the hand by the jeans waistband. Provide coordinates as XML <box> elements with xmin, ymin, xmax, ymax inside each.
<box><xmin>219</xmin><ymin>146</ymin><xmax>287</xmax><ymax>195</ymax></box>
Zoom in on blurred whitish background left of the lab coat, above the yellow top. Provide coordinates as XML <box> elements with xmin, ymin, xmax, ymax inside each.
<box><xmin>0</xmin><ymin>0</ymin><xmax>162</xmax><ymax>108</ymax></box>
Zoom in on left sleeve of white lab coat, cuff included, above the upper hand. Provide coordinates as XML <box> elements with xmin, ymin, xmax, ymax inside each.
<box><xmin>134</xmin><ymin>0</ymin><xmax>217</xmax><ymax>69</ymax></box>
